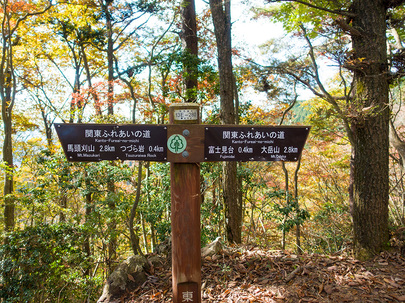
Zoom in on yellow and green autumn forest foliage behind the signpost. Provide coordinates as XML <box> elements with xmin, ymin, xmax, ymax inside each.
<box><xmin>0</xmin><ymin>0</ymin><xmax>405</xmax><ymax>302</ymax></box>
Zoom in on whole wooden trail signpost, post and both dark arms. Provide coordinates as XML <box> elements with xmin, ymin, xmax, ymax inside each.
<box><xmin>55</xmin><ymin>103</ymin><xmax>310</xmax><ymax>303</ymax></box>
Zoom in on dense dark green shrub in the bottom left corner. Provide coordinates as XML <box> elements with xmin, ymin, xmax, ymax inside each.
<box><xmin>0</xmin><ymin>224</ymin><xmax>100</xmax><ymax>303</ymax></box>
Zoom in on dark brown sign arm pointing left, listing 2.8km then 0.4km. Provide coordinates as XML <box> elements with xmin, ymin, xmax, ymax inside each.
<box><xmin>55</xmin><ymin>123</ymin><xmax>167</xmax><ymax>162</ymax></box>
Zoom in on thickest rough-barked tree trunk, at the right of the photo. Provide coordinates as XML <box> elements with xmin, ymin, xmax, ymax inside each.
<box><xmin>352</xmin><ymin>0</ymin><xmax>390</xmax><ymax>259</ymax></box>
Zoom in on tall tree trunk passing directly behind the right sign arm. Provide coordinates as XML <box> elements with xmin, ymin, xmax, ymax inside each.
<box><xmin>210</xmin><ymin>0</ymin><xmax>242</xmax><ymax>243</ymax></box>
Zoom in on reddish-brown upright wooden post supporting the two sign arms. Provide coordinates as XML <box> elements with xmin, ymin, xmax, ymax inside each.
<box><xmin>168</xmin><ymin>103</ymin><xmax>201</xmax><ymax>303</ymax></box>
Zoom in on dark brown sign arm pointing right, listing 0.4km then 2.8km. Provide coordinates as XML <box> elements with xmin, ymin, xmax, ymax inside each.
<box><xmin>204</xmin><ymin>125</ymin><xmax>310</xmax><ymax>162</ymax></box>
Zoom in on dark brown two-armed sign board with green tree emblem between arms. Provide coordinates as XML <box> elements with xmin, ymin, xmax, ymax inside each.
<box><xmin>55</xmin><ymin>124</ymin><xmax>310</xmax><ymax>163</ymax></box>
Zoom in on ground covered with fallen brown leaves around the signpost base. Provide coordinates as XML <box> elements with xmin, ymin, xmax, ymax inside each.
<box><xmin>120</xmin><ymin>247</ymin><xmax>405</xmax><ymax>303</ymax></box>
